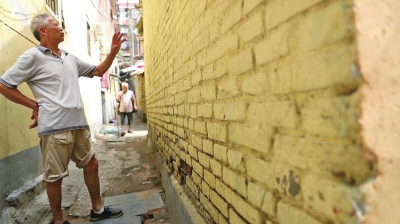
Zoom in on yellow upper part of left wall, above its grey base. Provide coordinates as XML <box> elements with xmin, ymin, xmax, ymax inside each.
<box><xmin>0</xmin><ymin>0</ymin><xmax>45</xmax><ymax>159</ymax></box>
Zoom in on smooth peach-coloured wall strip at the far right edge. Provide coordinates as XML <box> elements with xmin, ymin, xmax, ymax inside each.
<box><xmin>354</xmin><ymin>0</ymin><xmax>400</xmax><ymax>224</ymax></box>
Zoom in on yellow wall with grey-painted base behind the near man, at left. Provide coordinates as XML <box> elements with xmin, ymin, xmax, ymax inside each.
<box><xmin>0</xmin><ymin>0</ymin><xmax>45</xmax><ymax>210</ymax></box>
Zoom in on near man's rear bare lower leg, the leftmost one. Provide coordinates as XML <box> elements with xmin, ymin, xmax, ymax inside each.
<box><xmin>47</xmin><ymin>178</ymin><xmax>65</xmax><ymax>223</ymax></box>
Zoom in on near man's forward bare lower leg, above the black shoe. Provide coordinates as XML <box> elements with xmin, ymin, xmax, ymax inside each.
<box><xmin>83</xmin><ymin>156</ymin><xmax>103</xmax><ymax>211</ymax></box>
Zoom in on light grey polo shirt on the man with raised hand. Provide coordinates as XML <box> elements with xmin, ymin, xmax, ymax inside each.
<box><xmin>0</xmin><ymin>45</ymin><xmax>96</xmax><ymax>136</ymax></box>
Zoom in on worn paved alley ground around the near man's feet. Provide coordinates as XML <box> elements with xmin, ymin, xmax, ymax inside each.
<box><xmin>6</xmin><ymin>115</ymin><xmax>170</xmax><ymax>224</ymax></box>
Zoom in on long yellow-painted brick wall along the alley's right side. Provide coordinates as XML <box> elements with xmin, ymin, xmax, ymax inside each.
<box><xmin>143</xmin><ymin>0</ymin><xmax>375</xmax><ymax>224</ymax></box>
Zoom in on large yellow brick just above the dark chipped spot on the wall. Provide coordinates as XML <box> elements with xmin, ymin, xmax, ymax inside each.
<box><xmin>274</xmin><ymin>135</ymin><xmax>370</xmax><ymax>183</ymax></box>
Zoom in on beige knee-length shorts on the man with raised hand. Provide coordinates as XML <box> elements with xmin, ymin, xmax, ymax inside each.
<box><xmin>40</xmin><ymin>129</ymin><xmax>95</xmax><ymax>182</ymax></box>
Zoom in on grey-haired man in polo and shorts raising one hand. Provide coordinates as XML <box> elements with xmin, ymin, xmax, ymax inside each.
<box><xmin>0</xmin><ymin>13</ymin><xmax>125</xmax><ymax>224</ymax></box>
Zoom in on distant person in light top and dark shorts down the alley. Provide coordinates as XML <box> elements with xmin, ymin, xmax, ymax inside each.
<box><xmin>116</xmin><ymin>82</ymin><xmax>137</xmax><ymax>136</ymax></box>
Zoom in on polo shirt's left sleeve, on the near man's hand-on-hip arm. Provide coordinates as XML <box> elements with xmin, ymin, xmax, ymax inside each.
<box><xmin>0</xmin><ymin>53</ymin><xmax>37</xmax><ymax>88</ymax></box>
